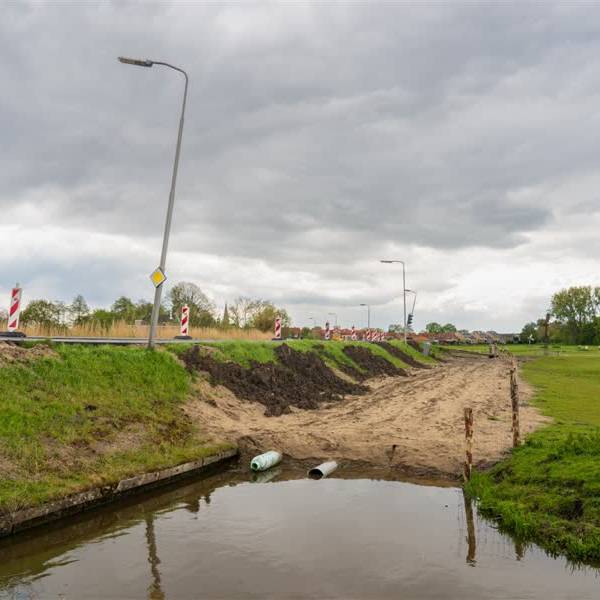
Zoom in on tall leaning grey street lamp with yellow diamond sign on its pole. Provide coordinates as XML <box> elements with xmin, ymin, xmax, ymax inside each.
<box><xmin>119</xmin><ymin>56</ymin><xmax>188</xmax><ymax>348</ymax></box>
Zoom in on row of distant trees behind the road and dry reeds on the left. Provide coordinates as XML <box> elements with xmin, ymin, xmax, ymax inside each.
<box><xmin>10</xmin><ymin>281</ymin><xmax>291</xmax><ymax>331</ymax></box>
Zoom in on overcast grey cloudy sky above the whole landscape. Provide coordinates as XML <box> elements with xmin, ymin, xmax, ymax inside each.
<box><xmin>0</xmin><ymin>0</ymin><xmax>600</xmax><ymax>331</ymax></box>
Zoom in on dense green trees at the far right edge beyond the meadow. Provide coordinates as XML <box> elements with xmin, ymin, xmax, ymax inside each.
<box><xmin>521</xmin><ymin>285</ymin><xmax>600</xmax><ymax>345</ymax></box>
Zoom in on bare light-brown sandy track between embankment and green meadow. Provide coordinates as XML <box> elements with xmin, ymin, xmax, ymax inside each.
<box><xmin>187</xmin><ymin>356</ymin><xmax>547</xmax><ymax>475</ymax></box>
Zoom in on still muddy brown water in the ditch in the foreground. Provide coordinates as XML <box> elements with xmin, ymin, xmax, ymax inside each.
<box><xmin>0</xmin><ymin>470</ymin><xmax>600</xmax><ymax>600</ymax></box>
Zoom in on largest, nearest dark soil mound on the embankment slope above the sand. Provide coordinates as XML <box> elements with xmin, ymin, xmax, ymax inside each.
<box><xmin>181</xmin><ymin>344</ymin><xmax>366</xmax><ymax>416</ymax></box>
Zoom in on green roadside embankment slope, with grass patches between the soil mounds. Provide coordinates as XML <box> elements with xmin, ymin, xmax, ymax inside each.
<box><xmin>0</xmin><ymin>340</ymin><xmax>427</xmax><ymax>512</ymax></box>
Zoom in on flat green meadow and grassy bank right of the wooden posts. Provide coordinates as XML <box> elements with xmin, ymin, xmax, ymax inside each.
<box><xmin>467</xmin><ymin>346</ymin><xmax>600</xmax><ymax>562</ymax></box>
